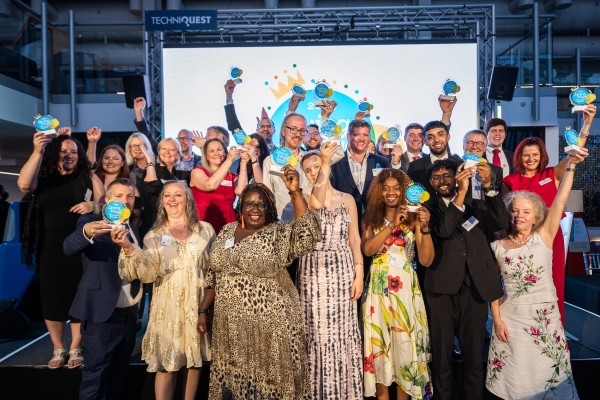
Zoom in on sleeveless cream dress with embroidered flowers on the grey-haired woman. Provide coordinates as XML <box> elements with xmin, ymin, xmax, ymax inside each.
<box><xmin>486</xmin><ymin>233</ymin><xmax>579</xmax><ymax>400</ymax></box>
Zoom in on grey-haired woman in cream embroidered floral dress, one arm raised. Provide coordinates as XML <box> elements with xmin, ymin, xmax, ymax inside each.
<box><xmin>486</xmin><ymin>156</ymin><xmax>584</xmax><ymax>400</ymax></box>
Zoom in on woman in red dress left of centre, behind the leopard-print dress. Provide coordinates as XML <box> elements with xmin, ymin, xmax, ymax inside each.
<box><xmin>190</xmin><ymin>138</ymin><xmax>250</xmax><ymax>234</ymax></box>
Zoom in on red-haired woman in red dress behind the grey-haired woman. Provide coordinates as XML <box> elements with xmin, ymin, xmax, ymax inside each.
<box><xmin>502</xmin><ymin>104</ymin><xmax>596</xmax><ymax>325</ymax></box>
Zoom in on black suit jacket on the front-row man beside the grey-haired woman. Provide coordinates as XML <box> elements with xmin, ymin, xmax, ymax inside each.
<box><xmin>419</xmin><ymin>194</ymin><xmax>510</xmax><ymax>302</ymax></box>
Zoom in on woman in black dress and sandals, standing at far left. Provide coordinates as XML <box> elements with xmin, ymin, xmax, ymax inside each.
<box><xmin>17</xmin><ymin>132</ymin><xmax>104</xmax><ymax>369</ymax></box>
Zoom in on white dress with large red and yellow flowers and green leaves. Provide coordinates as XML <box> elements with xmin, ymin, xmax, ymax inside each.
<box><xmin>362</xmin><ymin>221</ymin><xmax>433</xmax><ymax>400</ymax></box>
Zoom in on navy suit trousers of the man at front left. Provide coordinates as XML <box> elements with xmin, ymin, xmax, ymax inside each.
<box><xmin>79</xmin><ymin>306</ymin><xmax>137</xmax><ymax>400</ymax></box>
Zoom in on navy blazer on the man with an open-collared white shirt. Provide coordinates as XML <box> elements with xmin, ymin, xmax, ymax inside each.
<box><xmin>330</xmin><ymin>151</ymin><xmax>392</xmax><ymax>222</ymax></box>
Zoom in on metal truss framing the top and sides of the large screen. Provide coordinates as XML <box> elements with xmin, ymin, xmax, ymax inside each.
<box><xmin>147</xmin><ymin>4</ymin><xmax>496</xmax><ymax>136</ymax></box>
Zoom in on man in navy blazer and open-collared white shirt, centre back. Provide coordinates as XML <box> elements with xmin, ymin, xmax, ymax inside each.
<box><xmin>331</xmin><ymin>119</ymin><xmax>391</xmax><ymax>224</ymax></box>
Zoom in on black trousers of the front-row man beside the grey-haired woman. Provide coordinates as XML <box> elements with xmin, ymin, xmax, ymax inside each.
<box><xmin>423</xmin><ymin>283</ymin><xmax>488</xmax><ymax>400</ymax></box>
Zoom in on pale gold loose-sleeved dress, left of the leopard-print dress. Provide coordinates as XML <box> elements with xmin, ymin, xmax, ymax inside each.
<box><xmin>119</xmin><ymin>222</ymin><xmax>215</xmax><ymax>372</ymax></box>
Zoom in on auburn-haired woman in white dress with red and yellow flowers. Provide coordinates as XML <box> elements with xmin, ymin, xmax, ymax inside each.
<box><xmin>362</xmin><ymin>169</ymin><xmax>434</xmax><ymax>399</ymax></box>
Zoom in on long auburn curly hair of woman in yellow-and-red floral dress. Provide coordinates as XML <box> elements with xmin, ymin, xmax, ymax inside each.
<box><xmin>363</xmin><ymin>168</ymin><xmax>417</xmax><ymax>229</ymax></box>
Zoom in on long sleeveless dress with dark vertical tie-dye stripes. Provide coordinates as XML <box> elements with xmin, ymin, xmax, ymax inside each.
<box><xmin>297</xmin><ymin>205</ymin><xmax>363</xmax><ymax>400</ymax></box>
